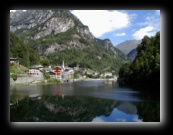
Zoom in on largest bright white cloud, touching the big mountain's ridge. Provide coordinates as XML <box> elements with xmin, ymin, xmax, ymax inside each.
<box><xmin>71</xmin><ymin>10</ymin><xmax>130</xmax><ymax>37</ymax></box>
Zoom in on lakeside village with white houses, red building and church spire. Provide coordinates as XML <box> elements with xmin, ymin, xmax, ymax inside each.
<box><xmin>10</xmin><ymin>58</ymin><xmax>117</xmax><ymax>84</ymax></box>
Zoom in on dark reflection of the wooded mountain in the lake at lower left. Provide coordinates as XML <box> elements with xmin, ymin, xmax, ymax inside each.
<box><xmin>10</xmin><ymin>95</ymin><xmax>115</xmax><ymax>122</ymax></box>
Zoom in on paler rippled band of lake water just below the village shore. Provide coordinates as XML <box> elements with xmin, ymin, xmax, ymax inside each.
<box><xmin>11</xmin><ymin>80</ymin><xmax>143</xmax><ymax>101</ymax></box>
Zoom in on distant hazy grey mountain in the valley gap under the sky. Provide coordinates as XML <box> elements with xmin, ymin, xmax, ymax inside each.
<box><xmin>116</xmin><ymin>40</ymin><xmax>141</xmax><ymax>55</ymax></box>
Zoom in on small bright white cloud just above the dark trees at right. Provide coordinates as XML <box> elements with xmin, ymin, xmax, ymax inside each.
<box><xmin>132</xmin><ymin>26</ymin><xmax>156</xmax><ymax>40</ymax></box>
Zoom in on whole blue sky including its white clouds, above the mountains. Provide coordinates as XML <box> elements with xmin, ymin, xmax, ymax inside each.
<box><xmin>71</xmin><ymin>10</ymin><xmax>160</xmax><ymax>46</ymax></box>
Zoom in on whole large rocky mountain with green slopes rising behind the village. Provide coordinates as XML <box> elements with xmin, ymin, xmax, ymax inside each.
<box><xmin>10</xmin><ymin>10</ymin><xmax>128</xmax><ymax>73</ymax></box>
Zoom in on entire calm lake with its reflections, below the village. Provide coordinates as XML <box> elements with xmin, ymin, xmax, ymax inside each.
<box><xmin>10</xmin><ymin>80</ymin><xmax>160</xmax><ymax>122</ymax></box>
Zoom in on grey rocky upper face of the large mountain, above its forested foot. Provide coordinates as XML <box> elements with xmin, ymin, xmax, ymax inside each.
<box><xmin>10</xmin><ymin>10</ymin><xmax>126</xmax><ymax>59</ymax></box>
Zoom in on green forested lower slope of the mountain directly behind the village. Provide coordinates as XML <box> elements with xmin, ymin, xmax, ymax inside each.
<box><xmin>47</xmin><ymin>45</ymin><xmax>123</xmax><ymax>74</ymax></box>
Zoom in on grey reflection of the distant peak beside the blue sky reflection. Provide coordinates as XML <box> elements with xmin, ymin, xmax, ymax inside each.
<box><xmin>117</xmin><ymin>102</ymin><xmax>137</xmax><ymax>114</ymax></box>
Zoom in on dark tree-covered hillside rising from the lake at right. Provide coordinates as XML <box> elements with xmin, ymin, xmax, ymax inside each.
<box><xmin>118</xmin><ymin>32</ymin><xmax>160</xmax><ymax>90</ymax></box>
